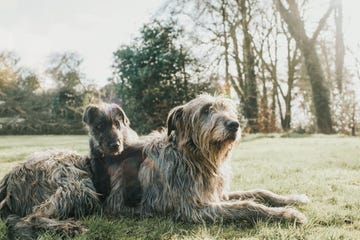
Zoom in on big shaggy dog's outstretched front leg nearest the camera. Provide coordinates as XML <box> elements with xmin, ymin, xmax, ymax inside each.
<box><xmin>195</xmin><ymin>201</ymin><xmax>307</xmax><ymax>223</ymax></box>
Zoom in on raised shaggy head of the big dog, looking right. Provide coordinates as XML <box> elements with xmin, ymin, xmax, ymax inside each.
<box><xmin>167</xmin><ymin>95</ymin><xmax>240</xmax><ymax>160</ymax></box>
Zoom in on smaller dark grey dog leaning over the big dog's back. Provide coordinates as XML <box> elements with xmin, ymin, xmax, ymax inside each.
<box><xmin>83</xmin><ymin>104</ymin><xmax>142</xmax><ymax>207</ymax></box>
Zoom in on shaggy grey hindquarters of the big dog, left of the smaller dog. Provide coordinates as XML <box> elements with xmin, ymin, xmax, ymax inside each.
<box><xmin>0</xmin><ymin>150</ymin><xmax>101</xmax><ymax>239</ymax></box>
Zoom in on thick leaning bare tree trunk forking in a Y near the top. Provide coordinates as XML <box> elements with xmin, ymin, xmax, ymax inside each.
<box><xmin>274</xmin><ymin>0</ymin><xmax>333</xmax><ymax>134</ymax></box>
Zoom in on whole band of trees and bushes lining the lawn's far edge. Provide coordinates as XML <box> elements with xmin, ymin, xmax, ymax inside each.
<box><xmin>0</xmin><ymin>0</ymin><xmax>360</xmax><ymax>135</ymax></box>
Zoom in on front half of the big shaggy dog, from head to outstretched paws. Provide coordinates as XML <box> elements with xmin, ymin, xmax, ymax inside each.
<box><xmin>105</xmin><ymin>95</ymin><xmax>308</xmax><ymax>223</ymax></box>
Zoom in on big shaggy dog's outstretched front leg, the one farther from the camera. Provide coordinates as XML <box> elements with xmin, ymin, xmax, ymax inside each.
<box><xmin>224</xmin><ymin>189</ymin><xmax>310</xmax><ymax>207</ymax></box>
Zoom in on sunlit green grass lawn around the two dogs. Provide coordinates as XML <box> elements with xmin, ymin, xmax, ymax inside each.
<box><xmin>0</xmin><ymin>135</ymin><xmax>360</xmax><ymax>240</ymax></box>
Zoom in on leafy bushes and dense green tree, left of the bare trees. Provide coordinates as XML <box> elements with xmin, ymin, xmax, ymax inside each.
<box><xmin>0</xmin><ymin>22</ymin><xmax>211</xmax><ymax>134</ymax></box>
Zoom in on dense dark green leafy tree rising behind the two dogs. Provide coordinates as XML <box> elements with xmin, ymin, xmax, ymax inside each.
<box><xmin>113</xmin><ymin>21</ymin><xmax>210</xmax><ymax>133</ymax></box>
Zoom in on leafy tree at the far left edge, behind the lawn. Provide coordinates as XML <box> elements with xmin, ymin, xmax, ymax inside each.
<box><xmin>0</xmin><ymin>53</ymin><xmax>49</xmax><ymax>134</ymax></box>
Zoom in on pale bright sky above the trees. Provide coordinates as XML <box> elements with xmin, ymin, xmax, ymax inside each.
<box><xmin>0</xmin><ymin>0</ymin><xmax>360</xmax><ymax>87</ymax></box>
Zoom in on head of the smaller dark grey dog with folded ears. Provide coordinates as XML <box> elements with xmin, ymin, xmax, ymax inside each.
<box><xmin>83</xmin><ymin>103</ymin><xmax>130</xmax><ymax>155</ymax></box>
